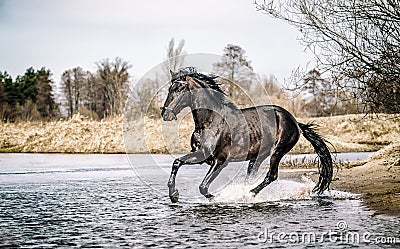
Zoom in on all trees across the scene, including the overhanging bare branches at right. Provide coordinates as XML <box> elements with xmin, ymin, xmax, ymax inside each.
<box><xmin>0</xmin><ymin>0</ymin><xmax>400</xmax><ymax>124</ymax></box>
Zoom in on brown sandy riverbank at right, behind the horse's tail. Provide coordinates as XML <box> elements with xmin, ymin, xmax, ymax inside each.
<box><xmin>332</xmin><ymin>143</ymin><xmax>400</xmax><ymax>218</ymax></box>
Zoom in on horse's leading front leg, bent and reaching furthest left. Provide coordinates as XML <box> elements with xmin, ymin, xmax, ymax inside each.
<box><xmin>168</xmin><ymin>151</ymin><xmax>206</xmax><ymax>203</ymax></box>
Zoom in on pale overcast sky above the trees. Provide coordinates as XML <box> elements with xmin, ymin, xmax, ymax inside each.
<box><xmin>0</xmin><ymin>0</ymin><xmax>311</xmax><ymax>83</ymax></box>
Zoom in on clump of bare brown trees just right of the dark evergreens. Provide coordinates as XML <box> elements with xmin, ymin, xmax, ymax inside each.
<box><xmin>61</xmin><ymin>58</ymin><xmax>130</xmax><ymax>119</ymax></box>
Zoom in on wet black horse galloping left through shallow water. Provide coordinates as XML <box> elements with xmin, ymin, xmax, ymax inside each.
<box><xmin>161</xmin><ymin>67</ymin><xmax>333</xmax><ymax>202</ymax></box>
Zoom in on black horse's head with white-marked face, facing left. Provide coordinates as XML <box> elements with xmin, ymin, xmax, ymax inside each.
<box><xmin>161</xmin><ymin>70</ymin><xmax>193</xmax><ymax>121</ymax></box>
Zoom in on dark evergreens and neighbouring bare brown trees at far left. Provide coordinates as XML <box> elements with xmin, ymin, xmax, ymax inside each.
<box><xmin>0</xmin><ymin>58</ymin><xmax>130</xmax><ymax>122</ymax></box>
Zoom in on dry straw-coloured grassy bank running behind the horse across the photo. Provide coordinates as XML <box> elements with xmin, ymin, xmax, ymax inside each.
<box><xmin>0</xmin><ymin>115</ymin><xmax>400</xmax><ymax>153</ymax></box>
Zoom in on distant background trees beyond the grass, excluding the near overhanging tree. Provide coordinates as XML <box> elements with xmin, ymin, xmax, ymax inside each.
<box><xmin>0</xmin><ymin>39</ymin><xmax>394</xmax><ymax>122</ymax></box>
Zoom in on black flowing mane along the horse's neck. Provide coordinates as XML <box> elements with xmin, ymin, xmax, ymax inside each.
<box><xmin>171</xmin><ymin>67</ymin><xmax>238</xmax><ymax>109</ymax></box>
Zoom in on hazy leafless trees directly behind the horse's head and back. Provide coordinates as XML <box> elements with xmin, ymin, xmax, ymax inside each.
<box><xmin>129</xmin><ymin>40</ymin><xmax>360</xmax><ymax>119</ymax></box>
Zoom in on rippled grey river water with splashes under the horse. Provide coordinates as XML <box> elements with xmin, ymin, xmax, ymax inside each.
<box><xmin>0</xmin><ymin>154</ymin><xmax>400</xmax><ymax>248</ymax></box>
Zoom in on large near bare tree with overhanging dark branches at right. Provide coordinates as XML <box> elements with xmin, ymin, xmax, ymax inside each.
<box><xmin>255</xmin><ymin>0</ymin><xmax>400</xmax><ymax>113</ymax></box>
